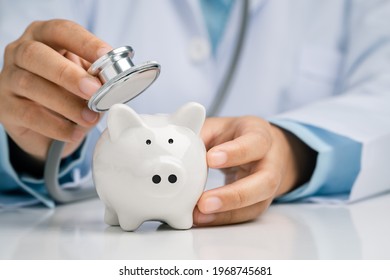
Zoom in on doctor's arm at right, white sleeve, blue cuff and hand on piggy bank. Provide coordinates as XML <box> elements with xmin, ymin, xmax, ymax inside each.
<box><xmin>194</xmin><ymin>1</ymin><xmax>390</xmax><ymax>225</ymax></box>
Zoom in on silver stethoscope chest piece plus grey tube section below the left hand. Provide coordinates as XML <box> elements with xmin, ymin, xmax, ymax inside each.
<box><xmin>44</xmin><ymin>46</ymin><xmax>160</xmax><ymax>203</ymax></box>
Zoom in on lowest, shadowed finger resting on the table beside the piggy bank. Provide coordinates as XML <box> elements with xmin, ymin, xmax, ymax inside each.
<box><xmin>193</xmin><ymin>199</ymin><xmax>272</xmax><ymax>226</ymax></box>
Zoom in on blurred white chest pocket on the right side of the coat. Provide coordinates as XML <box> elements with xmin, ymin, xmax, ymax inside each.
<box><xmin>288</xmin><ymin>46</ymin><xmax>341</xmax><ymax>108</ymax></box>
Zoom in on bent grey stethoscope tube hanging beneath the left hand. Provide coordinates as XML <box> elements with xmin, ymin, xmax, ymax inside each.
<box><xmin>44</xmin><ymin>140</ymin><xmax>97</xmax><ymax>203</ymax></box>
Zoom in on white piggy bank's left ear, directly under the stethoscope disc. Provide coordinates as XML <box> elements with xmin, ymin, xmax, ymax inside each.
<box><xmin>107</xmin><ymin>104</ymin><xmax>145</xmax><ymax>142</ymax></box>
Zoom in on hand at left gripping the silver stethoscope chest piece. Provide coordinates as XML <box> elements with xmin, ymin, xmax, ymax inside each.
<box><xmin>0</xmin><ymin>20</ymin><xmax>111</xmax><ymax>161</ymax></box>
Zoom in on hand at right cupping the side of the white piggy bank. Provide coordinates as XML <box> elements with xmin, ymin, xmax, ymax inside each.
<box><xmin>194</xmin><ymin>117</ymin><xmax>316</xmax><ymax>226</ymax></box>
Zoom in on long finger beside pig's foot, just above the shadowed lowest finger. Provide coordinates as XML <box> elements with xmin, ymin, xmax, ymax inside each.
<box><xmin>197</xmin><ymin>170</ymin><xmax>281</xmax><ymax>214</ymax></box>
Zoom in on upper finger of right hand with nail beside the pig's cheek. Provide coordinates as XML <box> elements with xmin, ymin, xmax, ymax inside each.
<box><xmin>207</xmin><ymin>130</ymin><xmax>272</xmax><ymax>168</ymax></box>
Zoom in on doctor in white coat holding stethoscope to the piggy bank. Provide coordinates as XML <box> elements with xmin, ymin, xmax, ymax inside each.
<box><xmin>0</xmin><ymin>0</ymin><xmax>390</xmax><ymax>225</ymax></box>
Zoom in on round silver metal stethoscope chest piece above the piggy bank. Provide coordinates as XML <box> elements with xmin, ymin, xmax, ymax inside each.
<box><xmin>88</xmin><ymin>46</ymin><xmax>160</xmax><ymax>112</ymax></box>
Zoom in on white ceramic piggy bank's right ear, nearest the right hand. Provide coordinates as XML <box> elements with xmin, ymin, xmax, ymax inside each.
<box><xmin>171</xmin><ymin>102</ymin><xmax>206</xmax><ymax>135</ymax></box>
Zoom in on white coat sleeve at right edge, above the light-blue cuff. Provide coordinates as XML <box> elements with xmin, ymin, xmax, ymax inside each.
<box><xmin>277</xmin><ymin>1</ymin><xmax>390</xmax><ymax>200</ymax></box>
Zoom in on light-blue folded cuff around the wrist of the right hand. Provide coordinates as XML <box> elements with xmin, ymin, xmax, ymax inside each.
<box><xmin>270</xmin><ymin>119</ymin><xmax>362</xmax><ymax>202</ymax></box>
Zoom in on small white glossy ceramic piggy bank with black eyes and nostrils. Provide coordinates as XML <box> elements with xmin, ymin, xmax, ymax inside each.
<box><xmin>92</xmin><ymin>103</ymin><xmax>207</xmax><ymax>231</ymax></box>
